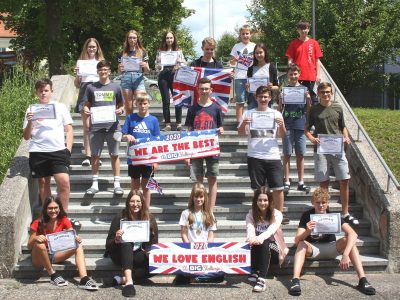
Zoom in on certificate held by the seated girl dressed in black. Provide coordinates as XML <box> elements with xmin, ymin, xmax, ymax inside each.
<box><xmin>120</xmin><ymin>220</ymin><xmax>150</xmax><ymax>243</ymax></box>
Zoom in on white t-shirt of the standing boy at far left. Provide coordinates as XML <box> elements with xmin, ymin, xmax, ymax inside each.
<box><xmin>23</xmin><ymin>101</ymin><xmax>72</xmax><ymax>152</ymax></box>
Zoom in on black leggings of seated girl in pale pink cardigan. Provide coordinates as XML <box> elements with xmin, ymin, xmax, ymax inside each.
<box><xmin>251</xmin><ymin>240</ymin><xmax>279</xmax><ymax>278</ymax></box>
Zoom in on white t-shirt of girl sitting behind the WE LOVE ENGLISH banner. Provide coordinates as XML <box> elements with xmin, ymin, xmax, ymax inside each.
<box><xmin>179</xmin><ymin>209</ymin><xmax>217</xmax><ymax>243</ymax></box>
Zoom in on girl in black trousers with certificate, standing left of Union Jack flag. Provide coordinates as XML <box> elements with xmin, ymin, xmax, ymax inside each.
<box><xmin>156</xmin><ymin>31</ymin><xmax>185</xmax><ymax>131</ymax></box>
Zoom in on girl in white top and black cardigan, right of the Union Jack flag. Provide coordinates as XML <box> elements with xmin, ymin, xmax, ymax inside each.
<box><xmin>246</xmin><ymin>43</ymin><xmax>279</xmax><ymax>109</ymax></box>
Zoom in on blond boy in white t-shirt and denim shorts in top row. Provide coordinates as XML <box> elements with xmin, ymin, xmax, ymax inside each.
<box><xmin>230</xmin><ymin>24</ymin><xmax>256</xmax><ymax>122</ymax></box>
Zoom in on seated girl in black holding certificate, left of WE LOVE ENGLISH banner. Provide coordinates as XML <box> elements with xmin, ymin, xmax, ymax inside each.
<box><xmin>106</xmin><ymin>190</ymin><xmax>158</xmax><ymax>297</ymax></box>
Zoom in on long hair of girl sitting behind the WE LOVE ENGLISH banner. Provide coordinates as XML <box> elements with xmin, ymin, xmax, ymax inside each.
<box><xmin>188</xmin><ymin>183</ymin><xmax>214</xmax><ymax>228</ymax></box>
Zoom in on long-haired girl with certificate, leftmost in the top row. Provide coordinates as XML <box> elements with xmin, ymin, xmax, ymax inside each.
<box><xmin>74</xmin><ymin>38</ymin><xmax>104</xmax><ymax>167</ymax></box>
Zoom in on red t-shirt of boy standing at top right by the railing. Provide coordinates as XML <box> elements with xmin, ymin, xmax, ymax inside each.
<box><xmin>285</xmin><ymin>38</ymin><xmax>322</xmax><ymax>81</ymax></box>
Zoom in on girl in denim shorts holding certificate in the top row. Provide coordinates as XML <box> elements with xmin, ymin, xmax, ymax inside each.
<box><xmin>118</xmin><ymin>30</ymin><xmax>150</xmax><ymax>116</ymax></box>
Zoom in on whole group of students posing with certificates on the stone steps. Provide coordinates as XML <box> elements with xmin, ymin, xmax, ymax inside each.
<box><xmin>24</xmin><ymin>22</ymin><xmax>375</xmax><ymax>296</ymax></box>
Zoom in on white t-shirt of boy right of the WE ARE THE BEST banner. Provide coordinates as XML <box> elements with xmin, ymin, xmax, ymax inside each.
<box><xmin>238</xmin><ymin>107</ymin><xmax>282</xmax><ymax>160</ymax></box>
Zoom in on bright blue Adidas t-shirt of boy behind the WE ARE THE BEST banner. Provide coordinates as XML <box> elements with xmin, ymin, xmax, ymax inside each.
<box><xmin>122</xmin><ymin>113</ymin><xmax>160</xmax><ymax>165</ymax></box>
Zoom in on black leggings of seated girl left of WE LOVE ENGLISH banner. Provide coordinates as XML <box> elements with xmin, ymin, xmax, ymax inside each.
<box><xmin>110</xmin><ymin>243</ymin><xmax>150</xmax><ymax>281</ymax></box>
